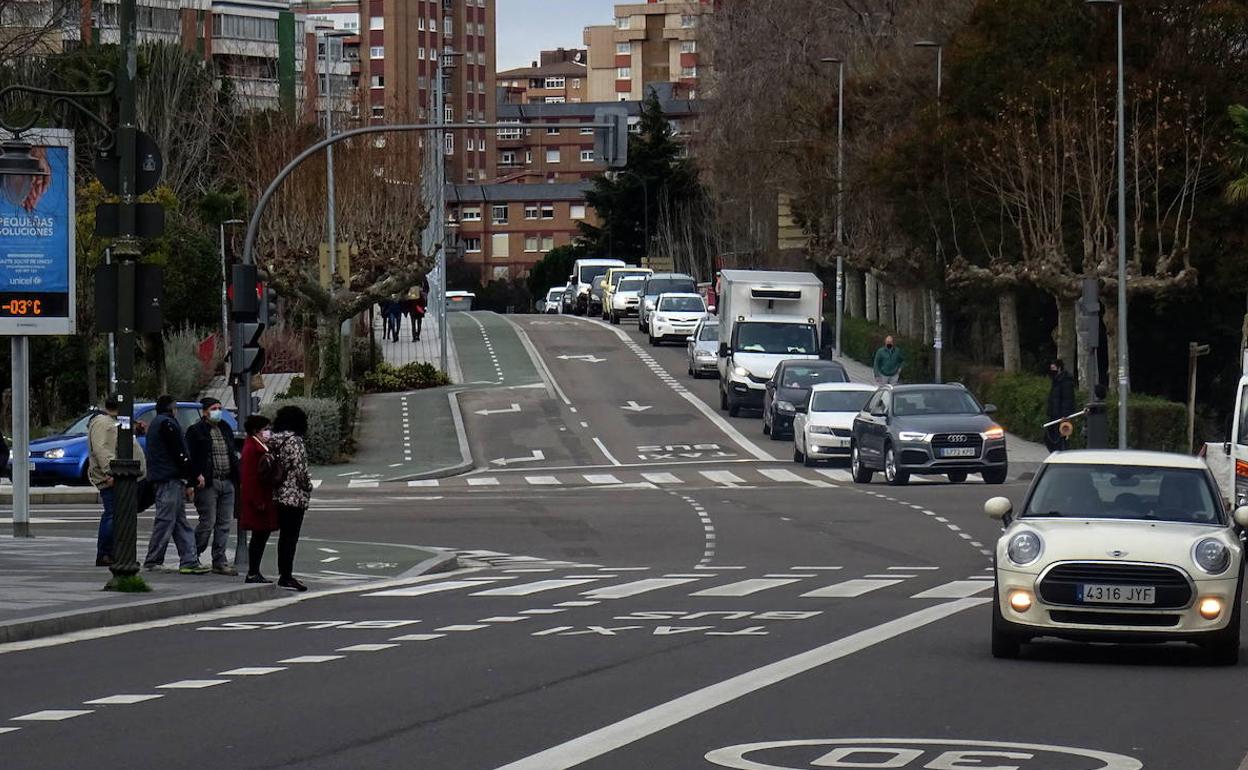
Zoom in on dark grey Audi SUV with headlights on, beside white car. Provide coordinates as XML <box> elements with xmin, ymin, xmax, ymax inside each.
<box><xmin>850</xmin><ymin>384</ymin><xmax>1008</xmax><ymax>485</ymax></box>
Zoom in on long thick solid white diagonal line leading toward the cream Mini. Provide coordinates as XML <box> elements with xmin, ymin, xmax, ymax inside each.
<box><xmin>498</xmin><ymin>599</ymin><xmax>986</xmax><ymax>770</ymax></box>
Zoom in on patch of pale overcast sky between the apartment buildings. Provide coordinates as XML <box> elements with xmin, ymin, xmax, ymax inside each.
<box><xmin>497</xmin><ymin>0</ymin><xmax>617</xmax><ymax>71</ymax></box>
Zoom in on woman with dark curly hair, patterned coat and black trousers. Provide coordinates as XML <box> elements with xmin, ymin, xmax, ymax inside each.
<box><xmin>270</xmin><ymin>406</ymin><xmax>312</xmax><ymax>592</ymax></box>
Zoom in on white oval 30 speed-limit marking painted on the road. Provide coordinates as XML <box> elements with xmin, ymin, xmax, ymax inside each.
<box><xmin>706</xmin><ymin>738</ymin><xmax>1143</xmax><ymax>770</ymax></box>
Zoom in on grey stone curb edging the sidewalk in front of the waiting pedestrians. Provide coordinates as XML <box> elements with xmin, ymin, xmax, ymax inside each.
<box><xmin>0</xmin><ymin>583</ymin><xmax>283</xmax><ymax>644</ymax></box>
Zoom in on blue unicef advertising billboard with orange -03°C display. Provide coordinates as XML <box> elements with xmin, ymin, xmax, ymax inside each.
<box><xmin>0</xmin><ymin>129</ymin><xmax>76</xmax><ymax>336</ymax></box>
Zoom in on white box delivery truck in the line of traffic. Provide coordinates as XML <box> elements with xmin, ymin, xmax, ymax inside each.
<box><xmin>718</xmin><ymin>270</ymin><xmax>824</xmax><ymax>417</ymax></box>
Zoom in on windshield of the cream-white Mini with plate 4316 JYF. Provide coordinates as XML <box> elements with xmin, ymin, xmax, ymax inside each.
<box><xmin>1022</xmin><ymin>464</ymin><xmax>1224</xmax><ymax>524</ymax></box>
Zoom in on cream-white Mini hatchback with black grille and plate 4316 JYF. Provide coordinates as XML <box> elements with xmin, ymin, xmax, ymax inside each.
<box><xmin>985</xmin><ymin>451</ymin><xmax>1248</xmax><ymax>665</ymax></box>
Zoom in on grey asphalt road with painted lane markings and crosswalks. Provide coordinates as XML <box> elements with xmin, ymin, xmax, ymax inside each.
<box><xmin>0</xmin><ymin>310</ymin><xmax>1248</xmax><ymax>770</ymax></box>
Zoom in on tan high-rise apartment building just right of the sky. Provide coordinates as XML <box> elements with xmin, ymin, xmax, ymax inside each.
<box><xmin>584</xmin><ymin>0</ymin><xmax>715</xmax><ymax>101</ymax></box>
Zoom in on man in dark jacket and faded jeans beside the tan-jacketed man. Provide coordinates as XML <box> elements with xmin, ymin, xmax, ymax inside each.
<box><xmin>144</xmin><ymin>396</ymin><xmax>208</xmax><ymax>575</ymax></box>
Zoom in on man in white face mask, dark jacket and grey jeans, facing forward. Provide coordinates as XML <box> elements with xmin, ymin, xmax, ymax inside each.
<box><xmin>186</xmin><ymin>396</ymin><xmax>238</xmax><ymax>575</ymax></box>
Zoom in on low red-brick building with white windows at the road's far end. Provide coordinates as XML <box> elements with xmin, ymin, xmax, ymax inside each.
<box><xmin>447</xmin><ymin>182</ymin><xmax>594</xmax><ymax>282</ymax></box>
